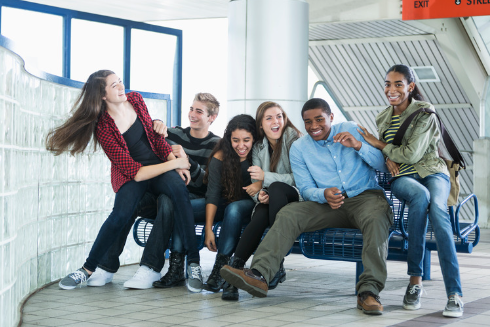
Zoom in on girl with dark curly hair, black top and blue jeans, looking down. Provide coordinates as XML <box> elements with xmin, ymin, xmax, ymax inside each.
<box><xmin>204</xmin><ymin>115</ymin><xmax>261</xmax><ymax>292</ymax></box>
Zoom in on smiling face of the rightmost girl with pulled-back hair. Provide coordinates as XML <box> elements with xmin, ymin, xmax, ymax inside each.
<box><xmin>385</xmin><ymin>72</ymin><xmax>415</xmax><ymax>111</ymax></box>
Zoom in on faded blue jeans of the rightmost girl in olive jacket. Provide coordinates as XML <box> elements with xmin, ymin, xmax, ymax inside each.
<box><xmin>391</xmin><ymin>173</ymin><xmax>463</xmax><ymax>297</ymax></box>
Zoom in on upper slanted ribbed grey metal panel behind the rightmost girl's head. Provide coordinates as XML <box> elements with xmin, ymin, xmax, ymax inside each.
<box><xmin>309</xmin><ymin>40</ymin><xmax>469</xmax><ymax>107</ymax></box>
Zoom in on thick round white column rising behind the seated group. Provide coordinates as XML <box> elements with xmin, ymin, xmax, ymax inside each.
<box><xmin>227</xmin><ymin>0</ymin><xmax>308</xmax><ymax>130</ymax></box>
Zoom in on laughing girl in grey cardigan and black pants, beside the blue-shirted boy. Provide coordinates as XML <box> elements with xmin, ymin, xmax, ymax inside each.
<box><xmin>221</xmin><ymin>101</ymin><xmax>303</xmax><ymax>301</ymax></box>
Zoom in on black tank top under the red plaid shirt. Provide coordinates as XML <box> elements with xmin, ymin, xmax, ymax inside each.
<box><xmin>123</xmin><ymin>117</ymin><xmax>163</xmax><ymax>166</ymax></box>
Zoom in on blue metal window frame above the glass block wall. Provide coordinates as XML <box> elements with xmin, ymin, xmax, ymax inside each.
<box><xmin>0</xmin><ymin>0</ymin><xmax>182</xmax><ymax>126</ymax></box>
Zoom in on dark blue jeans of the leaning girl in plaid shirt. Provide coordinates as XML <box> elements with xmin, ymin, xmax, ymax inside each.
<box><xmin>84</xmin><ymin>170</ymin><xmax>199</xmax><ymax>271</ymax></box>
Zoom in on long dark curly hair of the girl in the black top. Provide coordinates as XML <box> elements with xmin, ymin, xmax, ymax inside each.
<box><xmin>204</xmin><ymin>114</ymin><xmax>257</xmax><ymax>202</ymax></box>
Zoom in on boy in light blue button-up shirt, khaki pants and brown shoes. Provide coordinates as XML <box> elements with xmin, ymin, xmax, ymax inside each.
<box><xmin>221</xmin><ymin>99</ymin><xmax>393</xmax><ymax>315</ymax></box>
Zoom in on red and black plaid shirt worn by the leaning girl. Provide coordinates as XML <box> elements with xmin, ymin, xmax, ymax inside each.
<box><xmin>96</xmin><ymin>92</ymin><xmax>172</xmax><ymax>193</ymax></box>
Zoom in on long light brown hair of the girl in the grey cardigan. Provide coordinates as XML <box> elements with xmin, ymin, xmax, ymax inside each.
<box><xmin>255</xmin><ymin>101</ymin><xmax>301</xmax><ymax>172</ymax></box>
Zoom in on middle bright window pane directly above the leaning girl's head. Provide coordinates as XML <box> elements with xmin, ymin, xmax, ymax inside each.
<box><xmin>70</xmin><ymin>19</ymin><xmax>124</xmax><ymax>82</ymax></box>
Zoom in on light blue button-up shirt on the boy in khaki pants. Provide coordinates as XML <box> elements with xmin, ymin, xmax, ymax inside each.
<box><xmin>290</xmin><ymin>109</ymin><xmax>387</xmax><ymax>203</ymax></box>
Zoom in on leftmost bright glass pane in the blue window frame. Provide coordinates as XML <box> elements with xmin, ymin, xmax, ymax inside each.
<box><xmin>2</xmin><ymin>7</ymin><xmax>63</xmax><ymax>76</ymax></box>
